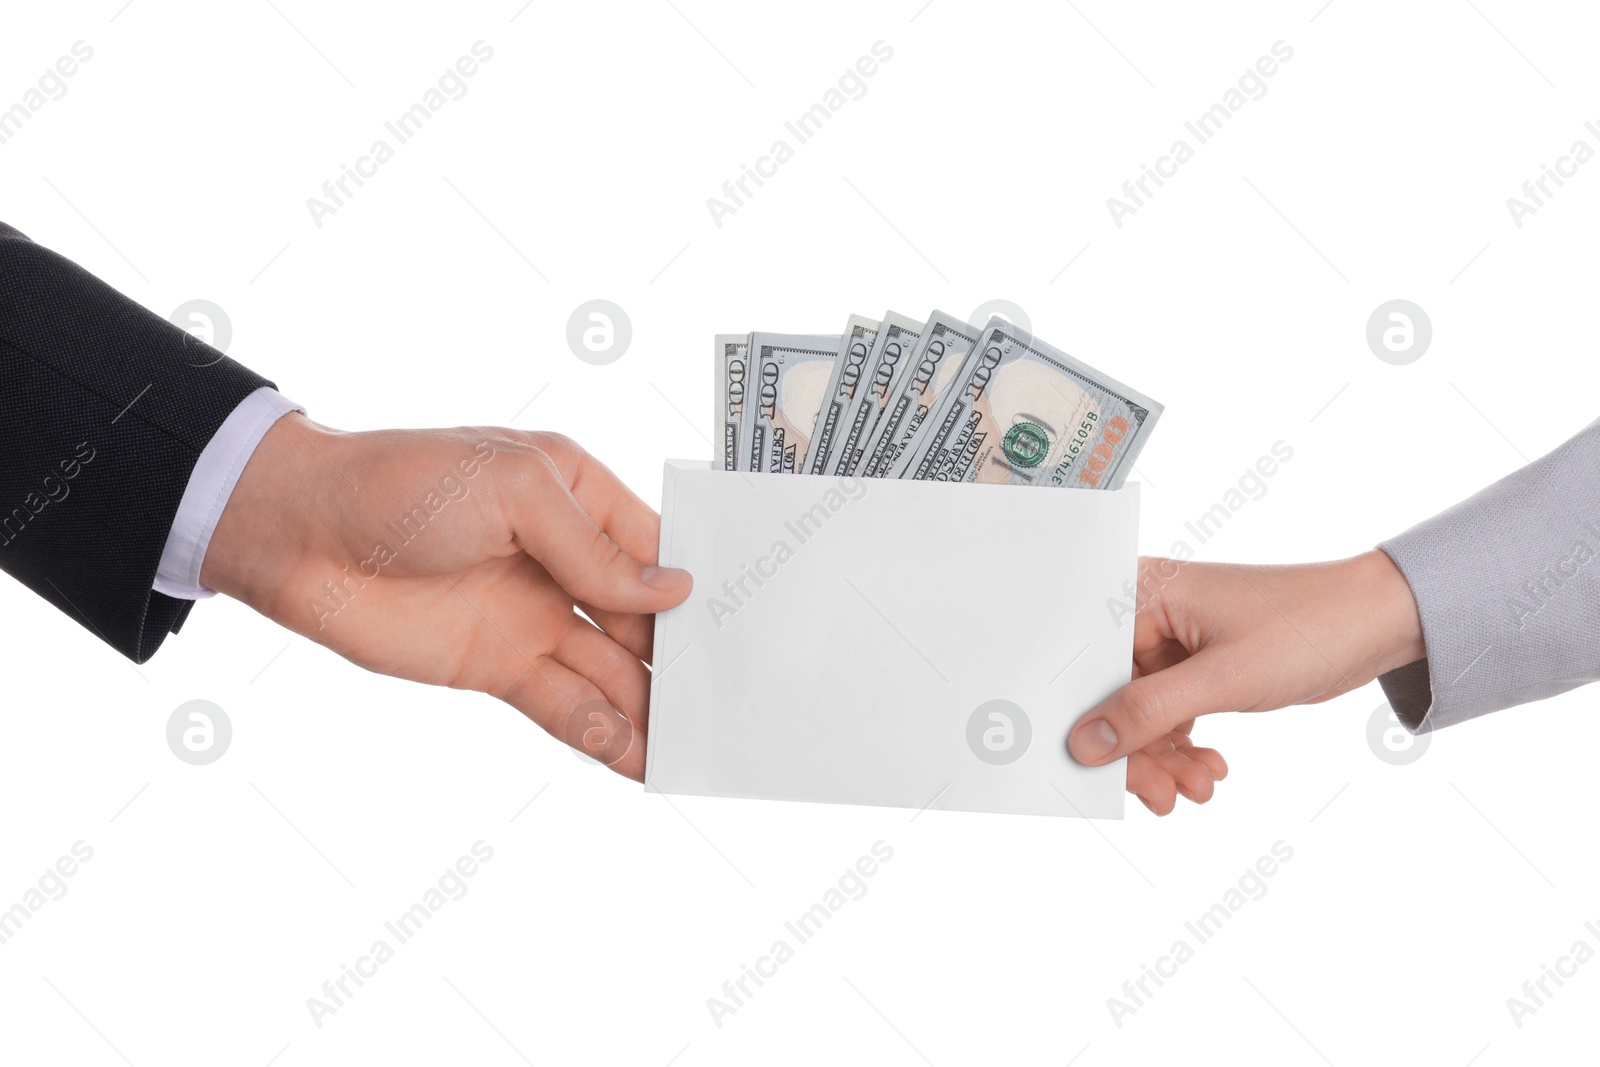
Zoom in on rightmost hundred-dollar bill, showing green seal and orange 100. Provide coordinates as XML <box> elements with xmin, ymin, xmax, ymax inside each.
<box><xmin>894</xmin><ymin>317</ymin><xmax>1162</xmax><ymax>490</ymax></box>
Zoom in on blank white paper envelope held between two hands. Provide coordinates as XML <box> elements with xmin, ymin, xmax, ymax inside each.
<box><xmin>645</xmin><ymin>459</ymin><xmax>1139</xmax><ymax>819</ymax></box>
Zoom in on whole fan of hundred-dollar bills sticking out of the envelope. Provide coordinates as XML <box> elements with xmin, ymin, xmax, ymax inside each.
<box><xmin>715</xmin><ymin>310</ymin><xmax>1162</xmax><ymax>490</ymax></box>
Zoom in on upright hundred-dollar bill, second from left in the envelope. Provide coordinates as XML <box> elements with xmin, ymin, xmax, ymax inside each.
<box><xmin>741</xmin><ymin>333</ymin><xmax>843</xmax><ymax>474</ymax></box>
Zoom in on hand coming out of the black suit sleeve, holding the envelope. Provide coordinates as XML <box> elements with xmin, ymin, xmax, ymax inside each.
<box><xmin>200</xmin><ymin>413</ymin><xmax>691</xmax><ymax>781</ymax></box>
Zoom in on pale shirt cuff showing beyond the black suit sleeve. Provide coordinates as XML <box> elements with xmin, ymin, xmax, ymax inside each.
<box><xmin>155</xmin><ymin>386</ymin><xmax>306</xmax><ymax>600</ymax></box>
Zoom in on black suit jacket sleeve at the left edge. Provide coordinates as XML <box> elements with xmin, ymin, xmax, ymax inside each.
<box><xmin>0</xmin><ymin>222</ymin><xmax>272</xmax><ymax>662</ymax></box>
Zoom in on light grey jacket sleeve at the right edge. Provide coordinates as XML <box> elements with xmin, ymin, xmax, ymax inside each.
<box><xmin>1378</xmin><ymin>421</ymin><xmax>1600</xmax><ymax>733</ymax></box>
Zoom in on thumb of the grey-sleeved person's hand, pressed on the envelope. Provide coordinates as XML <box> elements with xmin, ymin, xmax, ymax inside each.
<box><xmin>1067</xmin><ymin>654</ymin><xmax>1238</xmax><ymax>766</ymax></box>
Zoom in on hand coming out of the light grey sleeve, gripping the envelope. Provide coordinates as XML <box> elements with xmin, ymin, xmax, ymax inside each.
<box><xmin>1067</xmin><ymin>550</ymin><xmax>1426</xmax><ymax>816</ymax></box>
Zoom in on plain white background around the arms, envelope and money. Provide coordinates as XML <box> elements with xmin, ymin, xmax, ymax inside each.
<box><xmin>0</xmin><ymin>0</ymin><xmax>1600</xmax><ymax>1067</ymax></box>
